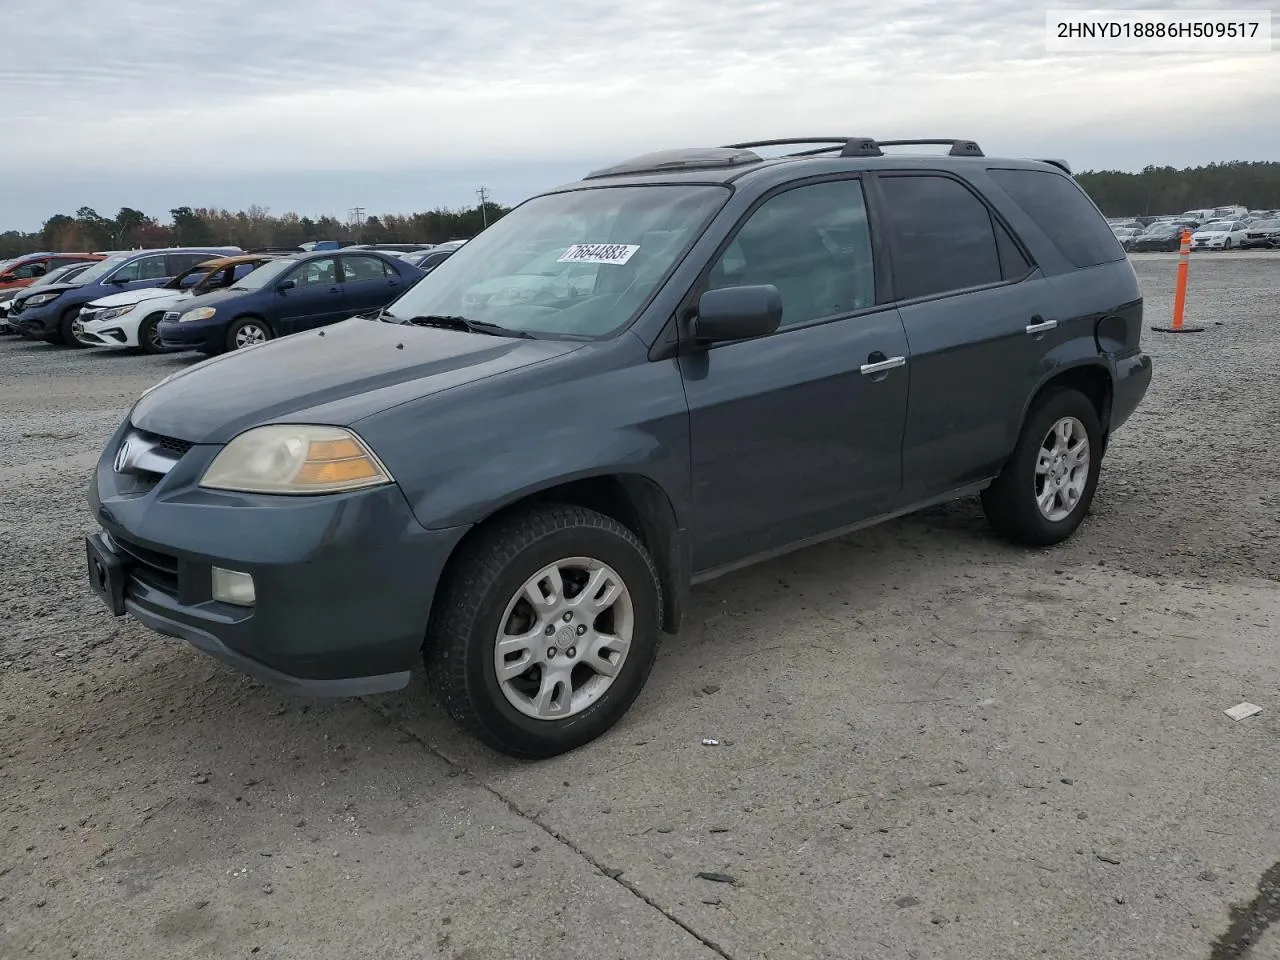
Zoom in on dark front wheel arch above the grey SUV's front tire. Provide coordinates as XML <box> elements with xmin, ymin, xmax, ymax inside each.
<box><xmin>431</xmin><ymin>472</ymin><xmax>691</xmax><ymax>634</ymax></box>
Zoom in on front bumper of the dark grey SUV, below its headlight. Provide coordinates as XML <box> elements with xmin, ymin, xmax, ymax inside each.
<box><xmin>90</xmin><ymin>424</ymin><xmax>466</xmax><ymax>696</ymax></box>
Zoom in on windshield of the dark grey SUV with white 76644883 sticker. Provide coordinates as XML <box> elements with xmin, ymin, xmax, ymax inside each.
<box><xmin>388</xmin><ymin>186</ymin><xmax>730</xmax><ymax>339</ymax></box>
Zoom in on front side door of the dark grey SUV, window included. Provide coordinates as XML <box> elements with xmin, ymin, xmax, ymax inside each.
<box><xmin>680</xmin><ymin>178</ymin><xmax>910</xmax><ymax>572</ymax></box>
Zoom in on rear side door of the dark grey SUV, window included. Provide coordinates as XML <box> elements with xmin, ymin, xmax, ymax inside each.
<box><xmin>876</xmin><ymin>172</ymin><xmax>1054</xmax><ymax>507</ymax></box>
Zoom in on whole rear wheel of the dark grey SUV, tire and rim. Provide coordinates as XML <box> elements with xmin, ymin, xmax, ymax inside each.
<box><xmin>982</xmin><ymin>388</ymin><xmax>1102</xmax><ymax>547</ymax></box>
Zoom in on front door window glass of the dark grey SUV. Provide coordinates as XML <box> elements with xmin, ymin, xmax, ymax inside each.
<box><xmin>708</xmin><ymin>180</ymin><xmax>876</xmax><ymax>326</ymax></box>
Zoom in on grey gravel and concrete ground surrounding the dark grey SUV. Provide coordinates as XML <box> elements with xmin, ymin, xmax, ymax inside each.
<box><xmin>0</xmin><ymin>255</ymin><xmax>1280</xmax><ymax>960</ymax></box>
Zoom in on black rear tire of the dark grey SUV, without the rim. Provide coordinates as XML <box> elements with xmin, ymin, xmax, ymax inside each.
<box><xmin>982</xmin><ymin>387</ymin><xmax>1102</xmax><ymax>547</ymax></box>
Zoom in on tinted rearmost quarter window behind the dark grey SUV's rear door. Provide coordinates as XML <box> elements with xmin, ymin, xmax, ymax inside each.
<box><xmin>987</xmin><ymin>170</ymin><xmax>1125</xmax><ymax>266</ymax></box>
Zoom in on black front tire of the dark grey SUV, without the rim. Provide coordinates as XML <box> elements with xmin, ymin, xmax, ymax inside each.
<box><xmin>424</xmin><ymin>504</ymin><xmax>662</xmax><ymax>760</ymax></box>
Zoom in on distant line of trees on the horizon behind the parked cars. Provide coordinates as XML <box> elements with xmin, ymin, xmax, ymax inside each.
<box><xmin>0</xmin><ymin>160</ymin><xmax>1280</xmax><ymax>260</ymax></box>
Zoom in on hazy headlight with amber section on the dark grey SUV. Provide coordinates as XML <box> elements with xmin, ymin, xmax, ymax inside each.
<box><xmin>200</xmin><ymin>424</ymin><xmax>392</xmax><ymax>494</ymax></box>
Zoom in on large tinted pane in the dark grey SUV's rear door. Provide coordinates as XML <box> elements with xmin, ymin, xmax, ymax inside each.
<box><xmin>879</xmin><ymin>177</ymin><xmax>998</xmax><ymax>300</ymax></box>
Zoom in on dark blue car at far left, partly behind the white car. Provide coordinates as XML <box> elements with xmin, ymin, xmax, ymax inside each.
<box><xmin>9</xmin><ymin>247</ymin><xmax>241</xmax><ymax>347</ymax></box>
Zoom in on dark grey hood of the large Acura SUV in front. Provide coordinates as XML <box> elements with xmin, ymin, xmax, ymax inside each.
<box><xmin>129</xmin><ymin>320</ymin><xmax>584</xmax><ymax>443</ymax></box>
